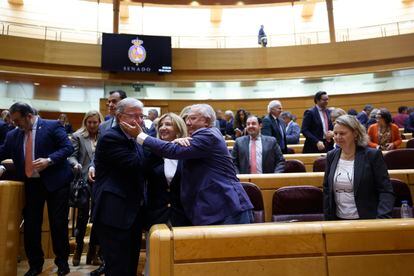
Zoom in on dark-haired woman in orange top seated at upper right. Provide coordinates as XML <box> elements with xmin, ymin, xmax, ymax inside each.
<box><xmin>368</xmin><ymin>108</ymin><xmax>402</xmax><ymax>150</ymax></box>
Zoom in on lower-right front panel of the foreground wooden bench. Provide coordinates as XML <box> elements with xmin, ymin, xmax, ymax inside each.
<box><xmin>328</xmin><ymin>253</ymin><xmax>414</xmax><ymax>276</ymax></box>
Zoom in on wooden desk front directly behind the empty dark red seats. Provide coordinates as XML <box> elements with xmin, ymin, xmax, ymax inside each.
<box><xmin>237</xmin><ymin>169</ymin><xmax>414</xmax><ymax>222</ymax></box>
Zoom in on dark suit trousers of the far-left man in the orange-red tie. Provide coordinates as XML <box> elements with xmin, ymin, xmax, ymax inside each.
<box><xmin>23</xmin><ymin>178</ymin><xmax>69</xmax><ymax>268</ymax></box>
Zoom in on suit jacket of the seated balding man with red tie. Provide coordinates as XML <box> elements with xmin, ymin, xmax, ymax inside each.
<box><xmin>231</xmin><ymin>135</ymin><xmax>285</xmax><ymax>173</ymax></box>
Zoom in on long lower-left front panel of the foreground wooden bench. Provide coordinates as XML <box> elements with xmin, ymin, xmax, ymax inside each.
<box><xmin>174</xmin><ymin>257</ymin><xmax>326</xmax><ymax>276</ymax></box>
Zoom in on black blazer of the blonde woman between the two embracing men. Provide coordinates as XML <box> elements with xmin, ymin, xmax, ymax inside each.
<box><xmin>145</xmin><ymin>154</ymin><xmax>191</xmax><ymax>230</ymax></box>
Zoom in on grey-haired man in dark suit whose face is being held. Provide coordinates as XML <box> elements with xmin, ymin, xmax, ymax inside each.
<box><xmin>92</xmin><ymin>98</ymin><xmax>144</xmax><ymax>276</ymax></box>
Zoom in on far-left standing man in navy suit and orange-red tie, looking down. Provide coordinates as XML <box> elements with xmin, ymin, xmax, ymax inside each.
<box><xmin>0</xmin><ymin>102</ymin><xmax>73</xmax><ymax>276</ymax></box>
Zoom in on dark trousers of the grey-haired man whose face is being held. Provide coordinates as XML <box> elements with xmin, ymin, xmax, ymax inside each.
<box><xmin>94</xmin><ymin>213</ymin><xmax>142</xmax><ymax>276</ymax></box>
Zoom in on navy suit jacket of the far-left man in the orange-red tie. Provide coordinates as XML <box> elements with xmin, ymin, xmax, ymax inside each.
<box><xmin>0</xmin><ymin>117</ymin><xmax>73</xmax><ymax>192</ymax></box>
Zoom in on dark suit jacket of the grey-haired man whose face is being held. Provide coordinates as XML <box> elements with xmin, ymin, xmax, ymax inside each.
<box><xmin>92</xmin><ymin>126</ymin><xmax>144</xmax><ymax>230</ymax></box>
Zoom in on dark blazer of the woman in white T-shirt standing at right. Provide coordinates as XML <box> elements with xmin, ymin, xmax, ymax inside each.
<box><xmin>323</xmin><ymin>147</ymin><xmax>395</xmax><ymax>220</ymax></box>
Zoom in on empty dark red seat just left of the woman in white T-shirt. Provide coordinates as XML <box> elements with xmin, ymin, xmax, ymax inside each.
<box><xmin>272</xmin><ymin>186</ymin><xmax>324</xmax><ymax>222</ymax></box>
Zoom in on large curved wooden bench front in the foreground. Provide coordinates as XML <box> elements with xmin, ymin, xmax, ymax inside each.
<box><xmin>150</xmin><ymin>219</ymin><xmax>414</xmax><ymax>276</ymax></box>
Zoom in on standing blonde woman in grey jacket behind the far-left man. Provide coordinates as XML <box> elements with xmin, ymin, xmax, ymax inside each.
<box><xmin>68</xmin><ymin>110</ymin><xmax>103</xmax><ymax>266</ymax></box>
